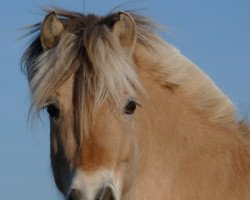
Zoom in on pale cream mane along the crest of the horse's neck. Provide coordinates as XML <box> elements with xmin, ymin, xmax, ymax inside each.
<box><xmin>135</xmin><ymin>40</ymin><xmax>235</xmax><ymax>126</ymax></box>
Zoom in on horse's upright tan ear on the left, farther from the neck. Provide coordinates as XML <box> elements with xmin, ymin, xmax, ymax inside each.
<box><xmin>41</xmin><ymin>12</ymin><xmax>64</xmax><ymax>51</ymax></box>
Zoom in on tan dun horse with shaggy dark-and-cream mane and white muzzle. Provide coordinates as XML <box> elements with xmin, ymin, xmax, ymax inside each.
<box><xmin>21</xmin><ymin>8</ymin><xmax>250</xmax><ymax>200</ymax></box>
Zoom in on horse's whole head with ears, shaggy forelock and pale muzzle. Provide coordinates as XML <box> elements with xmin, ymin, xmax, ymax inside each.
<box><xmin>31</xmin><ymin>12</ymin><xmax>140</xmax><ymax>200</ymax></box>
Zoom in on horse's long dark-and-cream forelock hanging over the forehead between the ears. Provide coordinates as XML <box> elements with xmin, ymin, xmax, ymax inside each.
<box><xmin>21</xmin><ymin>9</ymin><xmax>157</xmax><ymax>136</ymax></box>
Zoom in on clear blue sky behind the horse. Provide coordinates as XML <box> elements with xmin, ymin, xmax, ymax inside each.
<box><xmin>0</xmin><ymin>0</ymin><xmax>250</xmax><ymax>200</ymax></box>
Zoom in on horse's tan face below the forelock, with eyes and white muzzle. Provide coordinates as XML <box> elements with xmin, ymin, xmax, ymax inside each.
<box><xmin>47</xmin><ymin>79</ymin><xmax>139</xmax><ymax>200</ymax></box>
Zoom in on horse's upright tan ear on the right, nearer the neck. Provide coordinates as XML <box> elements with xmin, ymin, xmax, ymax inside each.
<box><xmin>112</xmin><ymin>12</ymin><xmax>136</xmax><ymax>52</ymax></box>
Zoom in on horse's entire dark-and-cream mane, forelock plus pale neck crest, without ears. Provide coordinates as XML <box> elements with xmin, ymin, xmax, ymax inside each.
<box><xmin>21</xmin><ymin>9</ymin><xmax>235</xmax><ymax>133</ymax></box>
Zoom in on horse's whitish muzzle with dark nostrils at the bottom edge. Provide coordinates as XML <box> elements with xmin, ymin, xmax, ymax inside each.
<box><xmin>66</xmin><ymin>170</ymin><xmax>120</xmax><ymax>200</ymax></box>
